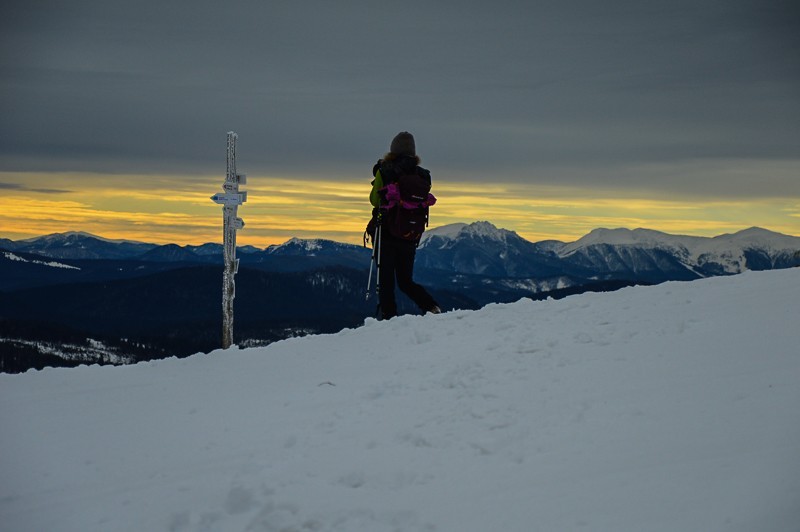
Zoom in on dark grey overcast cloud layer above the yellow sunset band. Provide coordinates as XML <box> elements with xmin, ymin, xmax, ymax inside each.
<box><xmin>0</xmin><ymin>0</ymin><xmax>800</xmax><ymax>241</ymax></box>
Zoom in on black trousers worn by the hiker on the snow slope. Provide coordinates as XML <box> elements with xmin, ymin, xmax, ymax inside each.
<box><xmin>379</xmin><ymin>231</ymin><xmax>437</xmax><ymax>319</ymax></box>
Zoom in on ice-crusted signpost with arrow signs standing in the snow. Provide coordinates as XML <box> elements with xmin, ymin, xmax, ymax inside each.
<box><xmin>211</xmin><ymin>131</ymin><xmax>247</xmax><ymax>349</ymax></box>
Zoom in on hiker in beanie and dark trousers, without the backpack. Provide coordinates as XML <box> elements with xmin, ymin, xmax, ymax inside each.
<box><xmin>369</xmin><ymin>131</ymin><xmax>442</xmax><ymax>320</ymax></box>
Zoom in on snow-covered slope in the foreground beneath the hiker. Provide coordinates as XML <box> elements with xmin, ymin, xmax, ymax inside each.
<box><xmin>0</xmin><ymin>269</ymin><xmax>800</xmax><ymax>532</ymax></box>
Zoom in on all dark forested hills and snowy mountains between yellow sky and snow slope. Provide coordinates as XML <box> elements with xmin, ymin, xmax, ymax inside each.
<box><xmin>0</xmin><ymin>222</ymin><xmax>800</xmax><ymax>371</ymax></box>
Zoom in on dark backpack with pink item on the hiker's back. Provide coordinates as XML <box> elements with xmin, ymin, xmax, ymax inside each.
<box><xmin>376</xmin><ymin>160</ymin><xmax>436</xmax><ymax>243</ymax></box>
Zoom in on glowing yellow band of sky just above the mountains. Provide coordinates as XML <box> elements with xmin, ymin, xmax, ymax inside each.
<box><xmin>0</xmin><ymin>173</ymin><xmax>800</xmax><ymax>247</ymax></box>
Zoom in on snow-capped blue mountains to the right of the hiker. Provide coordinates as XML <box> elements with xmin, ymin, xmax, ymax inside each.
<box><xmin>420</xmin><ymin>222</ymin><xmax>800</xmax><ymax>282</ymax></box>
